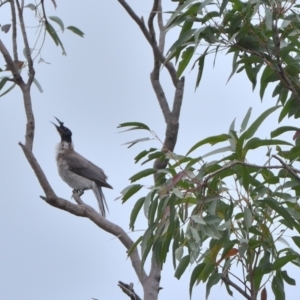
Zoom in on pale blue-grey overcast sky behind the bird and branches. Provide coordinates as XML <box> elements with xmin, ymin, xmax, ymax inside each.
<box><xmin>0</xmin><ymin>0</ymin><xmax>295</xmax><ymax>300</ymax></box>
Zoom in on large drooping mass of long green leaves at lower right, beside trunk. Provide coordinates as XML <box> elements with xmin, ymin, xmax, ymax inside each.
<box><xmin>120</xmin><ymin>98</ymin><xmax>300</xmax><ymax>299</ymax></box>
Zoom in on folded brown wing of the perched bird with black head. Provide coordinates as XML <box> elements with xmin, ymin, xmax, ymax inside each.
<box><xmin>64</xmin><ymin>152</ymin><xmax>112</xmax><ymax>189</ymax></box>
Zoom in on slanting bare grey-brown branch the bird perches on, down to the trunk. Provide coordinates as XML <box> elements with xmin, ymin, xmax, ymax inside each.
<box><xmin>19</xmin><ymin>143</ymin><xmax>147</xmax><ymax>284</ymax></box>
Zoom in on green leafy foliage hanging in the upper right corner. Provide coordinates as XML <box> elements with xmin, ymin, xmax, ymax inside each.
<box><xmin>166</xmin><ymin>0</ymin><xmax>300</xmax><ymax>121</ymax></box>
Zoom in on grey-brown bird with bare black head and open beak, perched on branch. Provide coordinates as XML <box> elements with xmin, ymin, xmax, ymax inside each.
<box><xmin>51</xmin><ymin>117</ymin><xmax>113</xmax><ymax>217</ymax></box>
